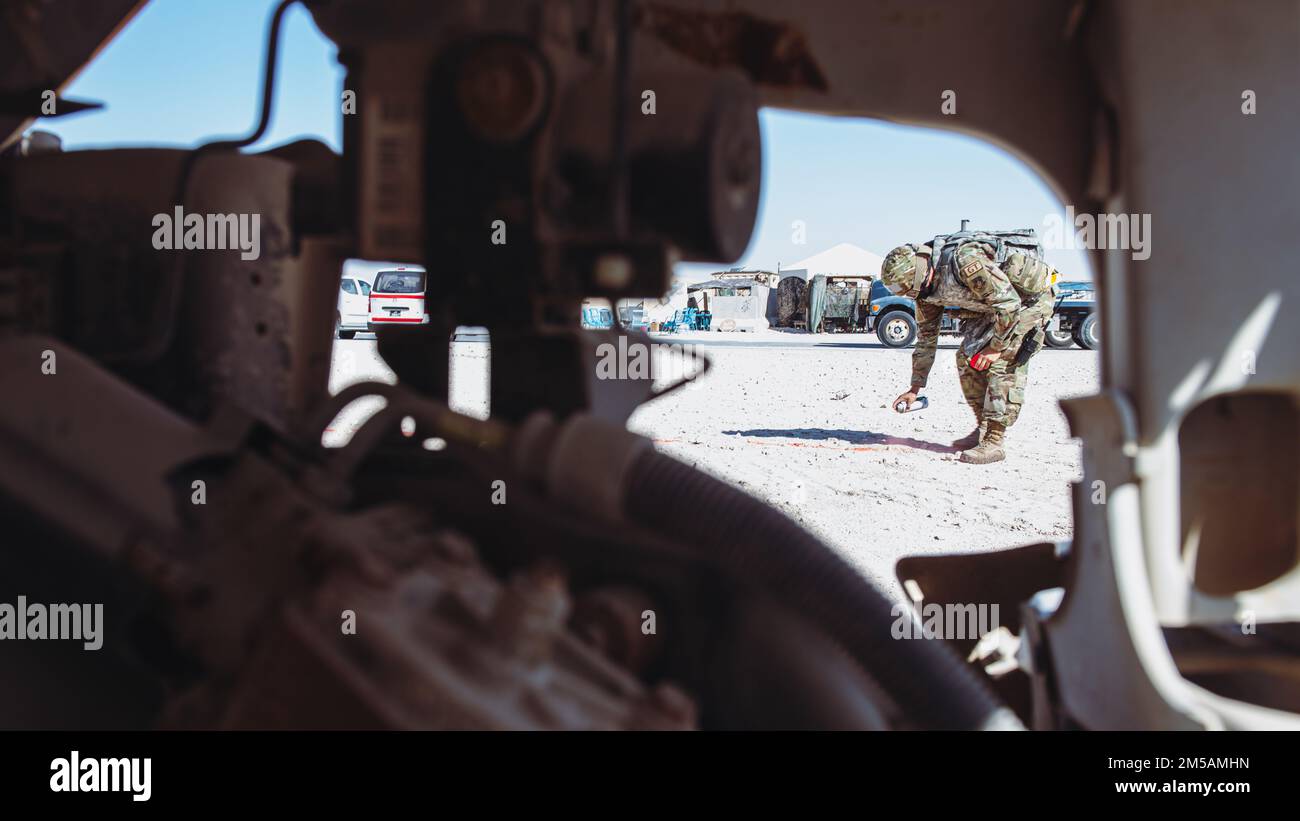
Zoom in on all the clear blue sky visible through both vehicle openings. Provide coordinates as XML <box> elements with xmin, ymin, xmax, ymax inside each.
<box><xmin>40</xmin><ymin>0</ymin><xmax>1088</xmax><ymax>279</ymax></box>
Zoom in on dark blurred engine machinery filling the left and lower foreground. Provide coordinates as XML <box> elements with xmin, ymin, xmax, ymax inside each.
<box><xmin>0</xmin><ymin>1</ymin><xmax>1003</xmax><ymax>729</ymax></box>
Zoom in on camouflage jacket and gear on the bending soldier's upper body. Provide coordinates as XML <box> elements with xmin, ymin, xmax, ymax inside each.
<box><xmin>911</xmin><ymin>242</ymin><xmax>1058</xmax><ymax>386</ymax></box>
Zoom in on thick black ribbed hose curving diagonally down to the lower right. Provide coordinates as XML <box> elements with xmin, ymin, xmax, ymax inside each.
<box><xmin>624</xmin><ymin>449</ymin><xmax>1019</xmax><ymax>730</ymax></box>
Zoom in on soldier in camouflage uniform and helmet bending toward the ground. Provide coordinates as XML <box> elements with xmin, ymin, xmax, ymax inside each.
<box><xmin>880</xmin><ymin>242</ymin><xmax>1057</xmax><ymax>465</ymax></box>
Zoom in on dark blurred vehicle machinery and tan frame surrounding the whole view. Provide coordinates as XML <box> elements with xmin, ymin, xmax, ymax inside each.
<box><xmin>0</xmin><ymin>0</ymin><xmax>1300</xmax><ymax>729</ymax></box>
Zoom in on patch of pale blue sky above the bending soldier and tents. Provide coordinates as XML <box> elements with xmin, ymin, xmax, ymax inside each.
<box><xmin>686</xmin><ymin>110</ymin><xmax>1088</xmax><ymax>279</ymax></box>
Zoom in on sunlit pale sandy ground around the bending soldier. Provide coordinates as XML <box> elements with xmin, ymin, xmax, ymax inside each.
<box><xmin>325</xmin><ymin>331</ymin><xmax>1099</xmax><ymax>595</ymax></box>
